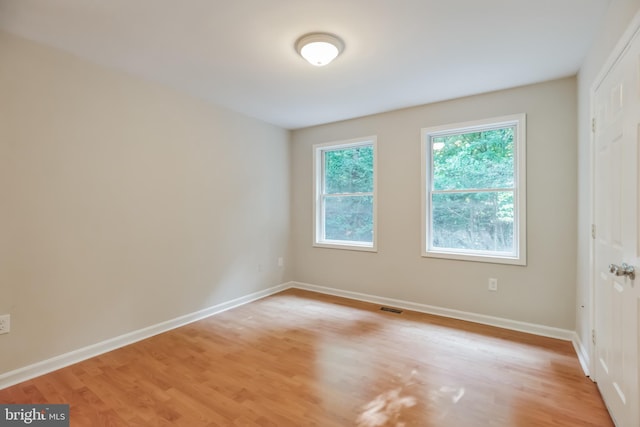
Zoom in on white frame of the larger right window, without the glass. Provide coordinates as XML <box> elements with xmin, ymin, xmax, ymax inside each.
<box><xmin>421</xmin><ymin>114</ymin><xmax>527</xmax><ymax>265</ymax></box>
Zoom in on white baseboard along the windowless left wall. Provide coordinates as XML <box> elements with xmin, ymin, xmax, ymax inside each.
<box><xmin>0</xmin><ymin>282</ymin><xmax>291</xmax><ymax>390</ymax></box>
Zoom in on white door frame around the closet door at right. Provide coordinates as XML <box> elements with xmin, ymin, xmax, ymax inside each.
<box><xmin>581</xmin><ymin>11</ymin><xmax>640</xmax><ymax>382</ymax></box>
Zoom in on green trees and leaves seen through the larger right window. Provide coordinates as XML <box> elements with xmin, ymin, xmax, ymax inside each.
<box><xmin>430</xmin><ymin>126</ymin><xmax>515</xmax><ymax>252</ymax></box>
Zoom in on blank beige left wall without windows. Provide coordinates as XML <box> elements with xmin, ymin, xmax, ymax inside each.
<box><xmin>0</xmin><ymin>33</ymin><xmax>291</xmax><ymax>374</ymax></box>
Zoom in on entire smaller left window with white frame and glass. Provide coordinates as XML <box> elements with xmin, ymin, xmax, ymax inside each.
<box><xmin>313</xmin><ymin>137</ymin><xmax>376</xmax><ymax>251</ymax></box>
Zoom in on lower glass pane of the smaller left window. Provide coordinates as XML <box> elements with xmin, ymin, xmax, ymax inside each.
<box><xmin>324</xmin><ymin>196</ymin><xmax>373</xmax><ymax>243</ymax></box>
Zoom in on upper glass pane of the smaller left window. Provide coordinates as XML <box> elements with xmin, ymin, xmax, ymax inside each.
<box><xmin>324</xmin><ymin>145</ymin><xmax>373</xmax><ymax>194</ymax></box>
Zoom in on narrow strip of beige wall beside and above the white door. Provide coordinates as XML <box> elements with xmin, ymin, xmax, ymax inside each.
<box><xmin>576</xmin><ymin>0</ymin><xmax>640</xmax><ymax>362</ymax></box>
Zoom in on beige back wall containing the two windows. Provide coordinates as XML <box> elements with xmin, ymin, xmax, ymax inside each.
<box><xmin>292</xmin><ymin>78</ymin><xmax>577</xmax><ymax>330</ymax></box>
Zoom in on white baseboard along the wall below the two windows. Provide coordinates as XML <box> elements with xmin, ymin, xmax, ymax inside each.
<box><xmin>290</xmin><ymin>282</ymin><xmax>575</xmax><ymax>341</ymax></box>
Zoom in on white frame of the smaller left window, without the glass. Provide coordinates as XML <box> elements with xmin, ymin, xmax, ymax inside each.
<box><xmin>313</xmin><ymin>136</ymin><xmax>378</xmax><ymax>252</ymax></box>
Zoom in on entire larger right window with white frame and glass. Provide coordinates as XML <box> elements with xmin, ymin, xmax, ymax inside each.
<box><xmin>422</xmin><ymin>114</ymin><xmax>526</xmax><ymax>265</ymax></box>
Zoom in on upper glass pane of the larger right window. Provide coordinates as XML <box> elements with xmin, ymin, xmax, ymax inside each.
<box><xmin>431</xmin><ymin>126</ymin><xmax>514</xmax><ymax>190</ymax></box>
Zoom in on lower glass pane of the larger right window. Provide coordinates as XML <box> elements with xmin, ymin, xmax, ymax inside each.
<box><xmin>432</xmin><ymin>191</ymin><xmax>514</xmax><ymax>253</ymax></box>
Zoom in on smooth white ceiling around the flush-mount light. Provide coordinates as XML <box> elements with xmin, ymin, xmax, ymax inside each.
<box><xmin>0</xmin><ymin>0</ymin><xmax>610</xmax><ymax>129</ymax></box>
